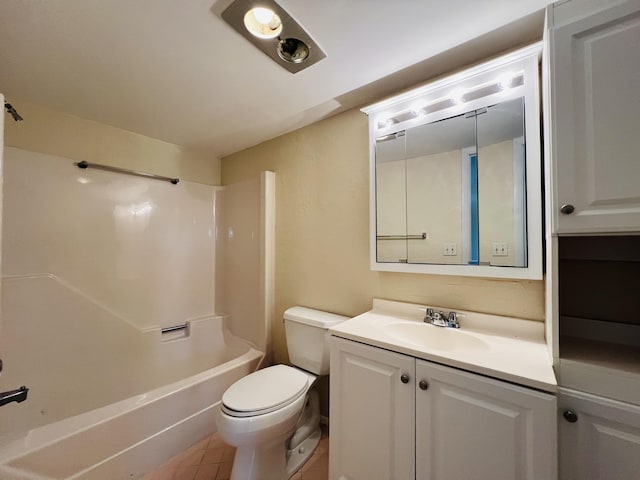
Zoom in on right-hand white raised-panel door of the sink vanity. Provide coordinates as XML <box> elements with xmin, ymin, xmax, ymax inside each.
<box><xmin>416</xmin><ymin>360</ymin><xmax>557</xmax><ymax>480</ymax></box>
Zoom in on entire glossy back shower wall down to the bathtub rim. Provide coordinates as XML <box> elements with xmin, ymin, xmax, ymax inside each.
<box><xmin>0</xmin><ymin>148</ymin><xmax>228</xmax><ymax>437</ymax></box>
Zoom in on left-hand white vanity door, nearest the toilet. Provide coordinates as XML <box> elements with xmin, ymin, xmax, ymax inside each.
<box><xmin>329</xmin><ymin>337</ymin><xmax>415</xmax><ymax>480</ymax></box>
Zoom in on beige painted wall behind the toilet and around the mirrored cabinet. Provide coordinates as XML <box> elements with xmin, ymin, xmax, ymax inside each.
<box><xmin>222</xmin><ymin>110</ymin><xmax>544</xmax><ymax>361</ymax></box>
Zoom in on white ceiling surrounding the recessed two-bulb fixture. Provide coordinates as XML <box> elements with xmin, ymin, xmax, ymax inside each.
<box><xmin>0</xmin><ymin>0</ymin><xmax>548</xmax><ymax>158</ymax></box>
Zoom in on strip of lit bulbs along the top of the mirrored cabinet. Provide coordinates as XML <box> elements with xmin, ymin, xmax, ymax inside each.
<box><xmin>377</xmin><ymin>72</ymin><xmax>524</xmax><ymax>130</ymax></box>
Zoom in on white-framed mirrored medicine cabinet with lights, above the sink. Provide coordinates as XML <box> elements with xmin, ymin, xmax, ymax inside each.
<box><xmin>363</xmin><ymin>45</ymin><xmax>542</xmax><ymax>279</ymax></box>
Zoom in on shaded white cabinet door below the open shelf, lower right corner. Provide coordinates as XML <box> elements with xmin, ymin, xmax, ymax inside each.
<box><xmin>558</xmin><ymin>389</ymin><xmax>640</xmax><ymax>480</ymax></box>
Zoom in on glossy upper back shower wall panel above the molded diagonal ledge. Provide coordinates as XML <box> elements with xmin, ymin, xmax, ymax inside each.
<box><xmin>2</xmin><ymin>148</ymin><xmax>215</xmax><ymax>335</ymax></box>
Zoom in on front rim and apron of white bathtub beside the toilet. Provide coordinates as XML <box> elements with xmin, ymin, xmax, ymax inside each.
<box><xmin>0</xmin><ymin>340</ymin><xmax>263</xmax><ymax>480</ymax></box>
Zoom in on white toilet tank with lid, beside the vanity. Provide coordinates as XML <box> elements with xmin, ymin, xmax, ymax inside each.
<box><xmin>284</xmin><ymin>307</ymin><xmax>349</xmax><ymax>375</ymax></box>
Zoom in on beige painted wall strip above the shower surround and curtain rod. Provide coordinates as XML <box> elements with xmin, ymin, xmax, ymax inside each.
<box><xmin>4</xmin><ymin>101</ymin><xmax>220</xmax><ymax>185</ymax></box>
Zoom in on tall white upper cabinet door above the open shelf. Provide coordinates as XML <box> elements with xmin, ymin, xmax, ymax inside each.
<box><xmin>550</xmin><ymin>0</ymin><xmax>640</xmax><ymax>233</ymax></box>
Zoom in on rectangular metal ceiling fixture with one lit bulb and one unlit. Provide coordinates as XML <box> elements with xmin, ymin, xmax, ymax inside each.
<box><xmin>222</xmin><ymin>0</ymin><xmax>326</xmax><ymax>73</ymax></box>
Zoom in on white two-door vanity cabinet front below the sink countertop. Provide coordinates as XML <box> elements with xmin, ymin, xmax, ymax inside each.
<box><xmin>329</xmin><ymin>337</ymin><xmax>556</xmax><ymax>480</ymax></box>
